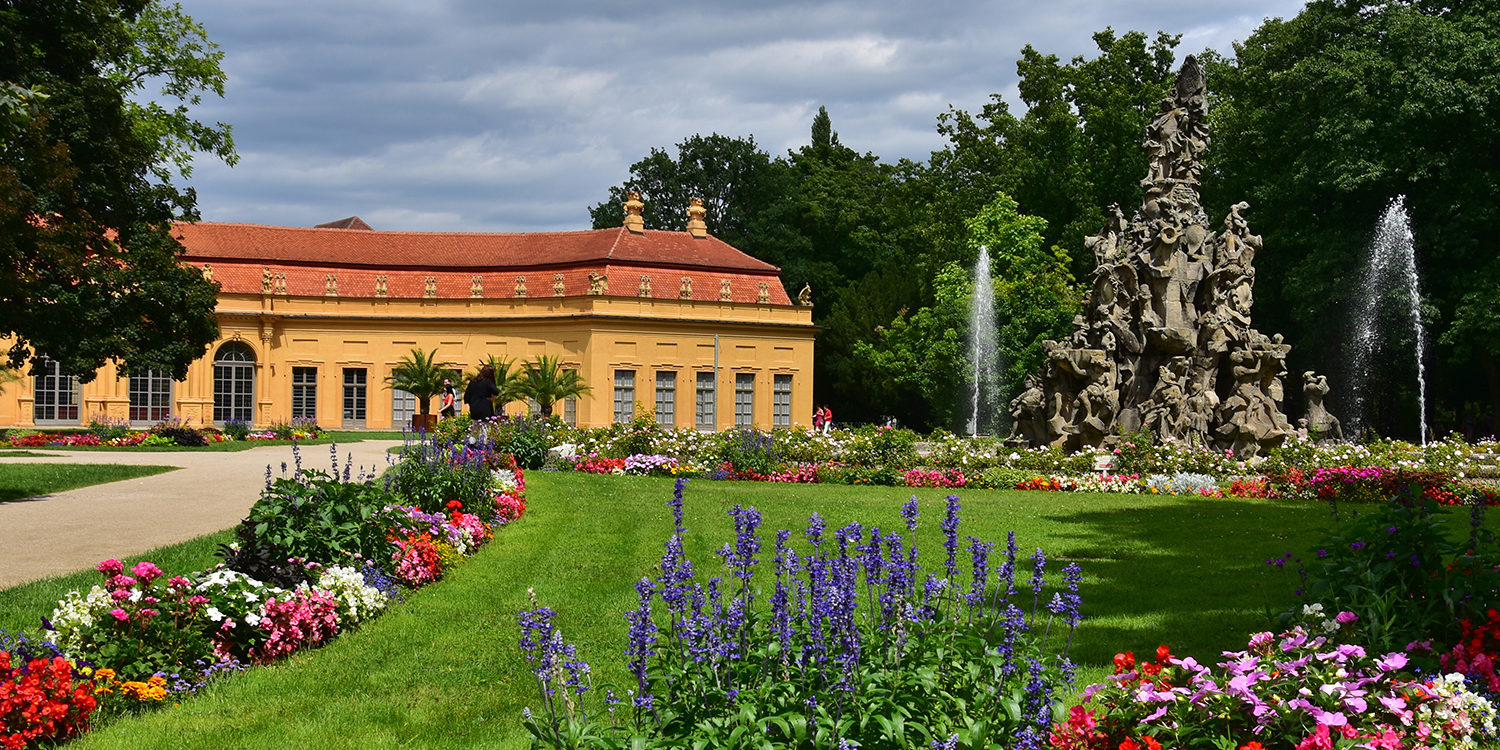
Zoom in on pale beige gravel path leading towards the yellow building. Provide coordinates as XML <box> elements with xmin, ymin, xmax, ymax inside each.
<box><xmin>0</xmin><ymin>440</ymin><xmax>401</xmax><ymax>588</ymax></box>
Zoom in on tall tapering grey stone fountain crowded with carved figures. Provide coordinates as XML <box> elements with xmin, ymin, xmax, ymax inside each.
<box><xmin>1010</xmin><ymin>57</ymin><xmax>1337</xmax><ymax>459</ymax></box>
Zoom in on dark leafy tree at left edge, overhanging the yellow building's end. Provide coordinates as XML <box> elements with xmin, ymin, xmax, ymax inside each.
<box><xmin>0</xmin><ymin>0</ymin><xmax>236</xmax><ymax>381</ymax></box>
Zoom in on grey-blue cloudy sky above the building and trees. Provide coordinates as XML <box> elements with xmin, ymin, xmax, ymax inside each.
<box><xmin>180</xmin><ymin>0</ymin><xmax>1302</xmax><ymax>231</ymax></box>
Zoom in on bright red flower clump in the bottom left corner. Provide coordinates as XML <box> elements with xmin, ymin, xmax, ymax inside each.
<box><xmin>0</xmin><ymin>651</ymin><xmax>98</xmax><ymax>750</ymax></box>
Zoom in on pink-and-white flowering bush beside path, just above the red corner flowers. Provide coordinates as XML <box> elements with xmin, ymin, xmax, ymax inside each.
<box><xmin>51</xmin><ymin>560</ymin><xmax>210</xmax><ymax>677</ymax></box>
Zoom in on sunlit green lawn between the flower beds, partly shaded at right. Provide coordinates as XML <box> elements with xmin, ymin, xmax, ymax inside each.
<box><xmin>17</xmin><ymin>471</ymin><xmax>1440</xmax><ymax>749</ymax></box>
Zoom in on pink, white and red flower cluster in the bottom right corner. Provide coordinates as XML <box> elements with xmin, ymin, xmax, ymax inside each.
<box><xmin>1052</xmin><ymin>612</ymin><xmax>1496</xmax><ymax>750</ymax></box>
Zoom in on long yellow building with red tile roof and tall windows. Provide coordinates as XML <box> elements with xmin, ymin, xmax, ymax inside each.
<box><xmin>0</xmin><ymin>201</ymin><xmax>816</xmax><ymax>431</ymax></box>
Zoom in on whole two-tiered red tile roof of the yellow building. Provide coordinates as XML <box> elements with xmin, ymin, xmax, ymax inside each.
<box><xmin>174</xmin><ymin>224</ymin><xmax>792</xmax><ymax>305</ymax></box>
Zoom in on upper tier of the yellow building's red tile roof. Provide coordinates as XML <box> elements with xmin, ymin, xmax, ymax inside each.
<box><xmin>174</xmin><ymin>222</ymin><xmax>779</xmax><ymax>273</ymax></box>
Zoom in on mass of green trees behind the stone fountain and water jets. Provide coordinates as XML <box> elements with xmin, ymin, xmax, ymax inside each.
<box><xmin>593</xmin><ymin>11</ymin><xmax>1500</xmax><ymax>437</ymax></box>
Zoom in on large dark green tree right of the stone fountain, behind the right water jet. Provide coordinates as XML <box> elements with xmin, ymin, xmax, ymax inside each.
<box><xmin>1205</xmin><ymin>0</ymin><xmax>1500</xmax><ymax>437</ymax></box>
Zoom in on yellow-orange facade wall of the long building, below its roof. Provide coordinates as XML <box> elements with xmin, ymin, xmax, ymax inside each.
<box><xmin>0</xmin><ymin>288</ymin><xmax>816</xmax><ymax>429</ymax></box>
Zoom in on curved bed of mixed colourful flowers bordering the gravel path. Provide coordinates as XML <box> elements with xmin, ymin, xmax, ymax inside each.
<box><xmin>0</xmin><ymin>438</ymin><xmax>525</xmax><ymax>750</ymax></box>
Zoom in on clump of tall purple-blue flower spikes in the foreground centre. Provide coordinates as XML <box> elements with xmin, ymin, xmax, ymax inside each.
<box><xmin>519</xmin><ymin>480</ymin><xmax>1082</xmax><ymax>749</ymax></box>
